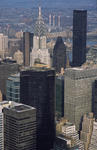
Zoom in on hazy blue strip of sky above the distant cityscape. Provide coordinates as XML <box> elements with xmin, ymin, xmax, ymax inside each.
<box><xmin>0</xmin><ymin>0</ymin><xmax>97</xmax><ymax>8</ymax></box>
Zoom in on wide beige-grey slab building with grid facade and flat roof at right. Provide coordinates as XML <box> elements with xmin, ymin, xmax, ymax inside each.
<box><xmin>64</xmin><ymin>67</ymin><xmax>97</xmax><ymax>130</ymax></box>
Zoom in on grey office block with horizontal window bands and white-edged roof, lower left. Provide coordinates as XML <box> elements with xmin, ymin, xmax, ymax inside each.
<box><xmin>3</xmin><ymin>102</ymin><xmax>36</xmax><ymax>150</ymax></box>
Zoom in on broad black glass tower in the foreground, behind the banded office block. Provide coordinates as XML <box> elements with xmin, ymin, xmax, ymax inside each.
<box><xmin>20</xmin><ymin>68</ymin><xmax>55</xmax><ymax>150</ymax></box>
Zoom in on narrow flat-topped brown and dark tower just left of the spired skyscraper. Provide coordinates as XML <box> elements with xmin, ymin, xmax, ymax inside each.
<box><xmin>23</xmin><ymin>32</ymin><xmax>34</xmax><ymax>66</ymax></box>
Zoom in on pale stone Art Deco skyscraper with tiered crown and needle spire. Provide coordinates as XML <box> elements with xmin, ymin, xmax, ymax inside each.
<box><xmin>30</xmin><ymin>7</ymin><xmax>50</xmax><ymax>66</ymax></box>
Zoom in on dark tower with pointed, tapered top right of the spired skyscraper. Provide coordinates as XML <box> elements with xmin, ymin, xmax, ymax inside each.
<box><xmin>53</xmin><ymin>37</ymin><xmax>66</xmax><ymax>72</ymax></box>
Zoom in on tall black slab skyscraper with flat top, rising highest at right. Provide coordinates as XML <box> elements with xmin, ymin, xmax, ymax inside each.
<box><xmin>73</xmin><ymin>10</ymin><xmax>87</xmax><ymax>67</ymax></box>
